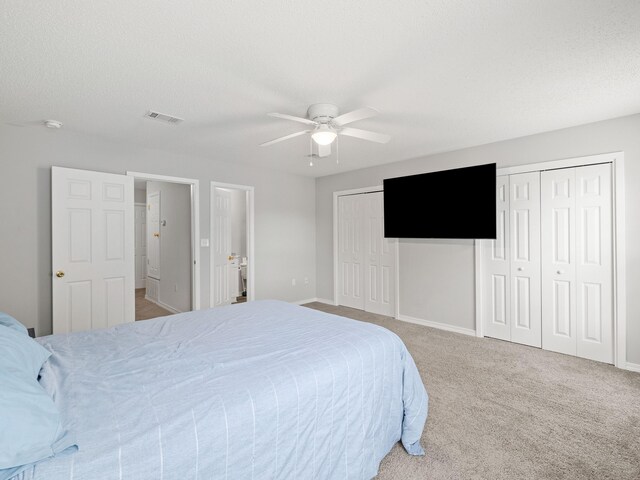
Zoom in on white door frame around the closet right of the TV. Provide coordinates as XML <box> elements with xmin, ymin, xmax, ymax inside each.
<box><xmin>474</xmin><ymin>152</ymin><xmax>629</xmax><ymax>369</ymax></box>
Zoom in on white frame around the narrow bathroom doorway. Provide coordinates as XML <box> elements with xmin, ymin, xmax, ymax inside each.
<box><xmin>209</xmin><ymin>181</ymin><xmax>256</xmax><ymax>308</ymax></box>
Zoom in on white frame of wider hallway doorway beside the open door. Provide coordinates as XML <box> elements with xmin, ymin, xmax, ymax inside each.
<box><xmin>127</xmin><ymin>171</ymin><xmax>201</xmax><ymax>310</ymax></box>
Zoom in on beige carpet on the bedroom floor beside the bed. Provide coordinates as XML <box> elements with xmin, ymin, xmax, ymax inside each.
<box><xmin>306</xmin><ymin>303</ymin><xmax>640</xmax><ymax>480</ymax></box>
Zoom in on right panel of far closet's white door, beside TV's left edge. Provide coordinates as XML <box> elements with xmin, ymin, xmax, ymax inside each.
<box><xmin>358</xmin><ymin>192</ymin><xmax>397</xmax><ymax>316</ymax></box>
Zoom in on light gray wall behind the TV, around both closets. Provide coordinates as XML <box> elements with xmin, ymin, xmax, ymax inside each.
<box><xmin>316</xmin><ymin>115</ymin><xmax>640</xmax><ymax>364</ymax></box>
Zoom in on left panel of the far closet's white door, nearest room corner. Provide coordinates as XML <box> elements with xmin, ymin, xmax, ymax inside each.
<box><xmin>338</xmin><ymin>195</ymin><xmax>365</xmax><ymax>310</ymax></box>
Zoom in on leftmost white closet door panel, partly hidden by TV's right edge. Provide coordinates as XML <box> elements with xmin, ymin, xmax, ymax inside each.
<box><xmin>481</xmin><ymin>176</ymin><xmax>511</xmax><ymax>340</ymax></box>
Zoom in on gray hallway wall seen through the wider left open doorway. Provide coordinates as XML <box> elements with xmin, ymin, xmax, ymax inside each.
<box><xmin>147</xmin><ymin>182</ymin><xmax>192</xmax><ymax>312</ymax></box>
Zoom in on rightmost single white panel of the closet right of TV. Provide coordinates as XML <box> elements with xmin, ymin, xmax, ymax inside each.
<box><xmin>576</xmin><ymin>164</ymin><xmax>613</xmax><ymax>363</ymax></box>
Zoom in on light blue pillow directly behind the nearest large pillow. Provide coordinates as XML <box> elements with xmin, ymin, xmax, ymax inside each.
<box><xmin>0</xmin><ymin>324</ymin><xmax>51</xmax><ymax>380</ymax></box>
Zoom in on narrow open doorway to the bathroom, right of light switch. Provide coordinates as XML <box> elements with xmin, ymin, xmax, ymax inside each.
<box><xmin>211</xmin><ymin>182</ymin><xmax>255</xmax><ymax>307</ymax></box>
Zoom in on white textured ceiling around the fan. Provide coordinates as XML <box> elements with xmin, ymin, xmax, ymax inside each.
<box><xmin>0</xmin><ymin>0</ymin><xmax>640</xmax><ymax>176</ymax></box>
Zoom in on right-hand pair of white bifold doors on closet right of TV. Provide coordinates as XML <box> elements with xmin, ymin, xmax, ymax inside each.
<box><xmin>542</xmin><ymin>164</ymin><xmax>613</xmax><ymax>363</ymax></box>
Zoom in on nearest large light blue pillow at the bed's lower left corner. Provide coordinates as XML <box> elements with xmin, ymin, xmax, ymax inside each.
<box><xmin>0</xmin><ymin>369</ymin><xmax>78</xmax><ymax>474</ymax></box>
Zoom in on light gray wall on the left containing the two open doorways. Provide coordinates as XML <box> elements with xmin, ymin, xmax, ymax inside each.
<box><xmin>0</xmin><ymin>125</ymin><xmax>316</xmax><ymax>335</ymax></box>
